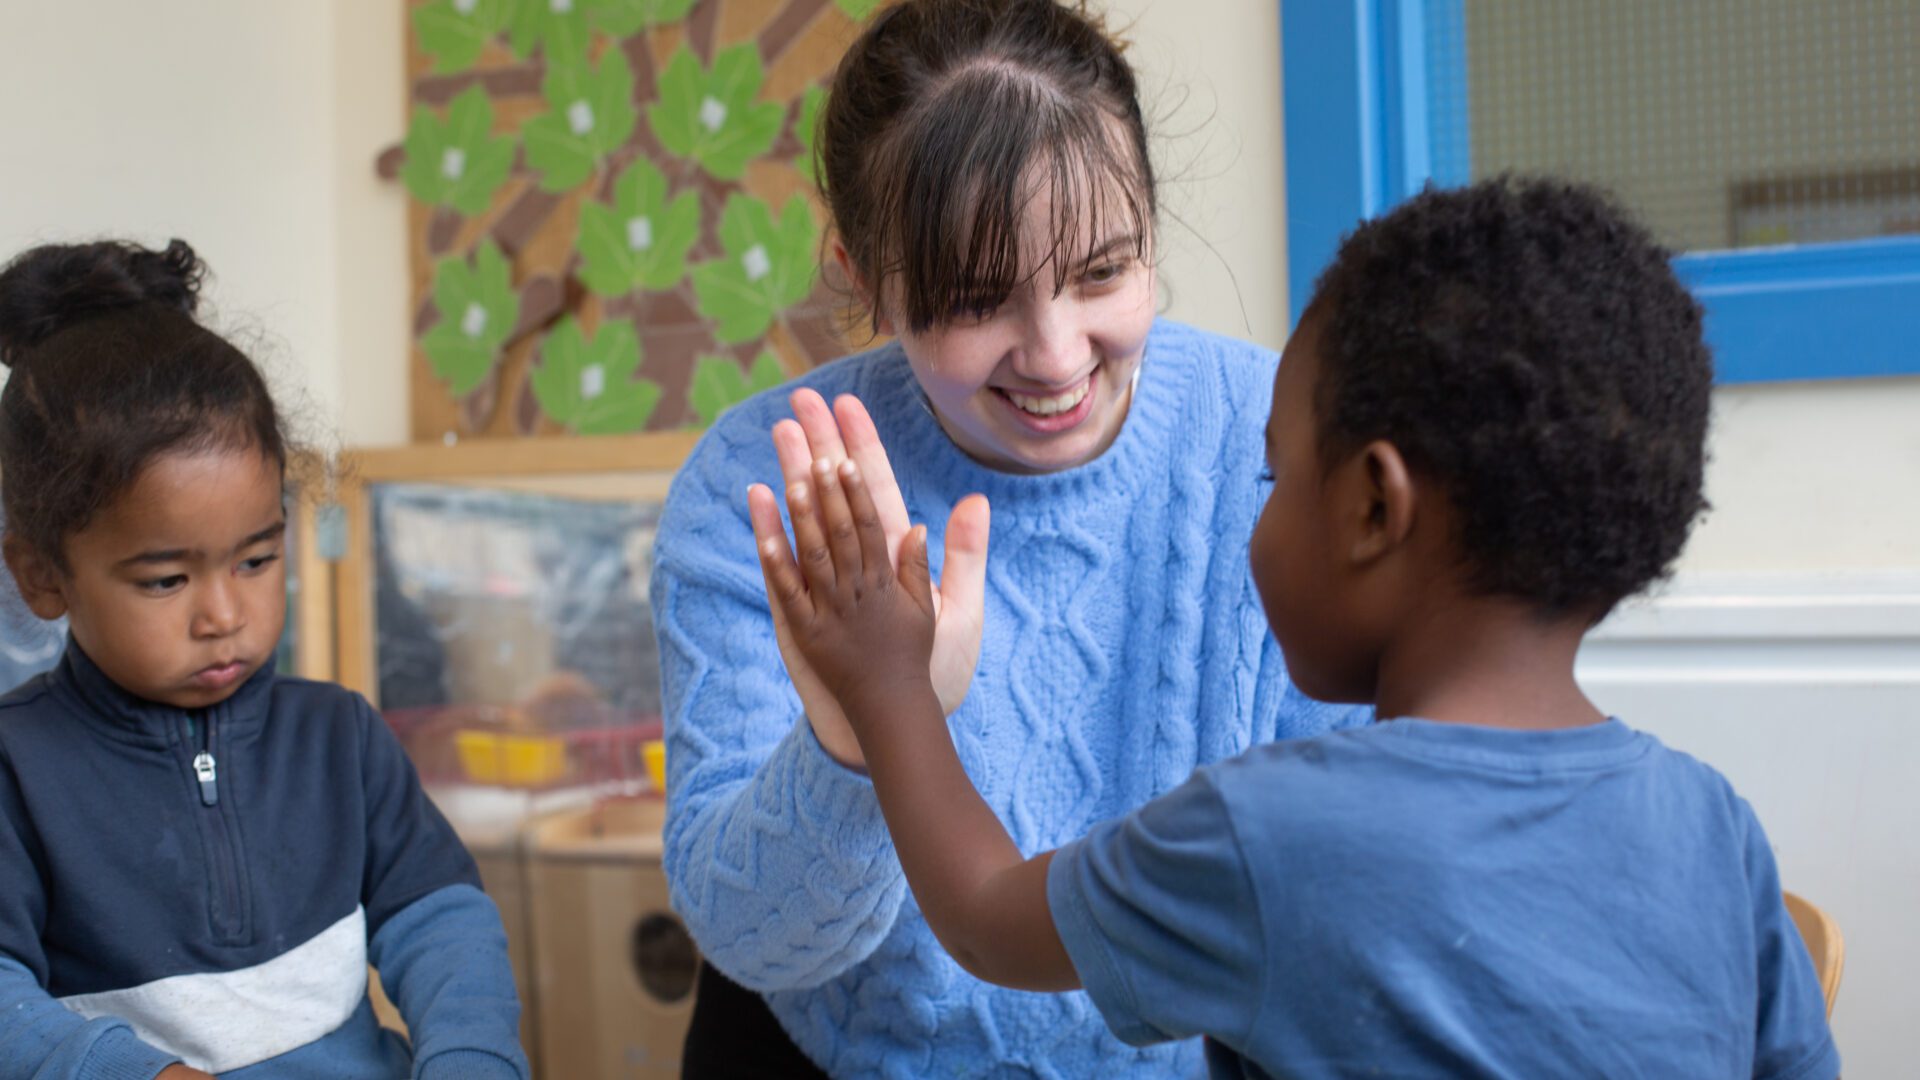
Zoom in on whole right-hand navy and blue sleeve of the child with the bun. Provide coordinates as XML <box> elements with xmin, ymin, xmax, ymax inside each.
<box><xmin>355</xmin><ymin>701</ymin><xmax>530</xmax><ymax>1080</ymax></box>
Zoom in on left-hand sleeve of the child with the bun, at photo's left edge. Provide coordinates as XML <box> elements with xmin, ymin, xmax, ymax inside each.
<box><xmin>0</xmin><ymin>755</ymin><xmax>179</xmax><ymax>1080</ymax></box>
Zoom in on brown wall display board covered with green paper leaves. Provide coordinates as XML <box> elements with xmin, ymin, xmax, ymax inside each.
<box><xmin>378</xmin><ymin>0</ymin><xmax>879</xmax><ymax>442</ymax></box>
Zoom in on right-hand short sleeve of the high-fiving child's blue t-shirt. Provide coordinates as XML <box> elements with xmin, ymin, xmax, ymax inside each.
<box><xmin>1740</xmin><ymin>799</ymin><xmax>1839</xmax><ymax>1080</ymax></box>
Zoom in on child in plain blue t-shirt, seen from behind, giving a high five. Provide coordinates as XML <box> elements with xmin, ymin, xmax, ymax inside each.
<box><xmin>749</xmin><ymin>179</ymin><xmax>1839</xmax><ymax>1080</ymax></box>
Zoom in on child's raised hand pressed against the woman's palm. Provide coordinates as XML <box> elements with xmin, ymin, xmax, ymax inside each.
<box><xmin>749</xmin><ymin>459</ymin><xmax>935</xmax><ymax>732</ymax></box>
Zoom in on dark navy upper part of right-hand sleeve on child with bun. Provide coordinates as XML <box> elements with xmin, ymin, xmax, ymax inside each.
<box><xmin>353</xmin><ymin>694</ymin><xmax>483</xmax><ymax>936</ymax></box>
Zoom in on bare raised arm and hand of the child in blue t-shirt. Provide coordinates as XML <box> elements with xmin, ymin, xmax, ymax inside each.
<box><xmin>749</xmin><ymin>461</ymin><xmax>1079</xmax><ymax>990</ymax></box>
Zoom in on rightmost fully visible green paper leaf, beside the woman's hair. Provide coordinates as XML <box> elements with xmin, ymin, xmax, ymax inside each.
<box><xmin>693</xmin><ymin>194</ymin><xmax>820</xmax><ymax>344</ymax></box>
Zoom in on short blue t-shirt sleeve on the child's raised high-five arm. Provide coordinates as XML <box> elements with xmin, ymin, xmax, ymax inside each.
<box><xmin>1046</xmin><ymin>773</ymin><xmax>1265</xmax><ymax>1045</ymax></box>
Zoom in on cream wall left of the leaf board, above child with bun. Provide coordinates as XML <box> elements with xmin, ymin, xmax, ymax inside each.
<box><xmin>0</xmin><ymin>0</ymin><xmax>407</xmax><ymax>444</ymax></box>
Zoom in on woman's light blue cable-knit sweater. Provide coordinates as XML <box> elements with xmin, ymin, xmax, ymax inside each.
<box><xmin>653</xmin><ymin>321</ymin><xmax>1367</xmax><ymax>1080</ymax></box>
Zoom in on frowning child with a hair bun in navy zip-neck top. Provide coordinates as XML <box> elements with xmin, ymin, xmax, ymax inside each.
<box><xmin>0</xmin><ymin>240</ymin><xmax>528</xmax><ymax>1080</ymax></box>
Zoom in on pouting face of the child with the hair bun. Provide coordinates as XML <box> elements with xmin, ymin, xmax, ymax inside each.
<box><xmin>45</xmin><ymin>448</ymin><xmax>286</xmax><ymax>709</ymax></box>
